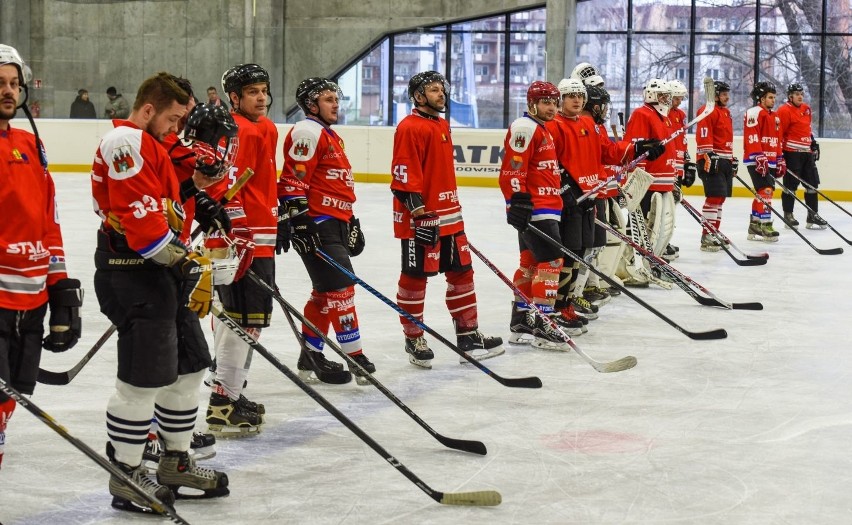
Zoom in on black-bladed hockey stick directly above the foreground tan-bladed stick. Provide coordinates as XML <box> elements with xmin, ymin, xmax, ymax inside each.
<box><xmin>248</xmin><ymin>270</ymin><xmax>487</xmax><ymax>456</ymax></box>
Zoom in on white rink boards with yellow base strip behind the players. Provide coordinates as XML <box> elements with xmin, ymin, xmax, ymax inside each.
<box><xmin>12</xmin><ymin>118</ymin><xmax>852</xmax><ymax>200</ymax></box>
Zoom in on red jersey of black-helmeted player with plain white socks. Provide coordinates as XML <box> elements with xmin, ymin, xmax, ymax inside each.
<box><xmin>205</xmin><ymin>112</ymin><xmax>278</xmax><ymax>258</ymax></box>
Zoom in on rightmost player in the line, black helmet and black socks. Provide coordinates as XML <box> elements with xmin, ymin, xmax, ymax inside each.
<box><xmin>778</xmin><ymin>82</ymin><xmax>828</xmax><ymax>230</ymax></box>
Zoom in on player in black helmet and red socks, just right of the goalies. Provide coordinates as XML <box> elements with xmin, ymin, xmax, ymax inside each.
<box><xmin>695</xmin><ymin>80</ymin><xmax>739</xmax><ymax>252</ymax></box>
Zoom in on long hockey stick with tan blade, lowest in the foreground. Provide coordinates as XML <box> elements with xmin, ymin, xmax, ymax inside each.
<box><xmin>210</xmin><ymin>304</ymin><xmax>503</xmax><ymax>506</ymax></box>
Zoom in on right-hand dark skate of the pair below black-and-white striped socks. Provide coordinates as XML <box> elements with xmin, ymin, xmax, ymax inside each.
<box><xmin>157</xmin><ymin>450</ymin><xmax>231</xmax><ymax>499</ymax></box>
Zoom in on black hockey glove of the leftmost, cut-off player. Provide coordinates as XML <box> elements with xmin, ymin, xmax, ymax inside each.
<box><xmin>41</xmin><ymin>279</ymin><xmax>83</xmax><ymax>352</ymax></box>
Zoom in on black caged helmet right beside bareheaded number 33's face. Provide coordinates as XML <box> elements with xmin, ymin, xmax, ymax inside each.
<box><xmin>183</xmin><ymin>104</ymin><xmax>238</xmax><ymax>179</ymax></box>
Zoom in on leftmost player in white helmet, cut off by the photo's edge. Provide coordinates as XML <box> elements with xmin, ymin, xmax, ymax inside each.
<box><xmin>0</xmin><ymin>44</ymin><xmax>83</xmax><ymax>465</ymax></box>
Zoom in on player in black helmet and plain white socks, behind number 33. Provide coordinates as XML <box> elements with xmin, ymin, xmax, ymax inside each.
<box><xmin>207</xmin><ymin>64</ymin><xmax>278</xmax><ymax>437</ymax></box>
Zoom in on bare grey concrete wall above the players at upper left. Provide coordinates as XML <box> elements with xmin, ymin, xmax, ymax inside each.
<box><xmin>0</xmin><ymin>0</ymin><xmax>552</xmax><ymax>121</ymax></box>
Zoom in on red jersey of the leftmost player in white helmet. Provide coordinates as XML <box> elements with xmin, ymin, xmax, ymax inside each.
<box><xmin>0</xmin><ymin>126</ymin><xmax>68</xmax><ymax>310</ymax></box>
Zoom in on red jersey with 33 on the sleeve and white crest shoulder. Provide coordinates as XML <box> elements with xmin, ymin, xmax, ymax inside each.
<box><xmin>92</xmin><ymin>120</ymin><xmax>180</xmax><ymax>259</ymax></box>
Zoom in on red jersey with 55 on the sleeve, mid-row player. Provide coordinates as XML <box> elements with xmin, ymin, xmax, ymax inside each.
<box><xmin>391</xmin><ymin>109</ymin><xmax>464</xmax><ymax>239</ymax></box>
